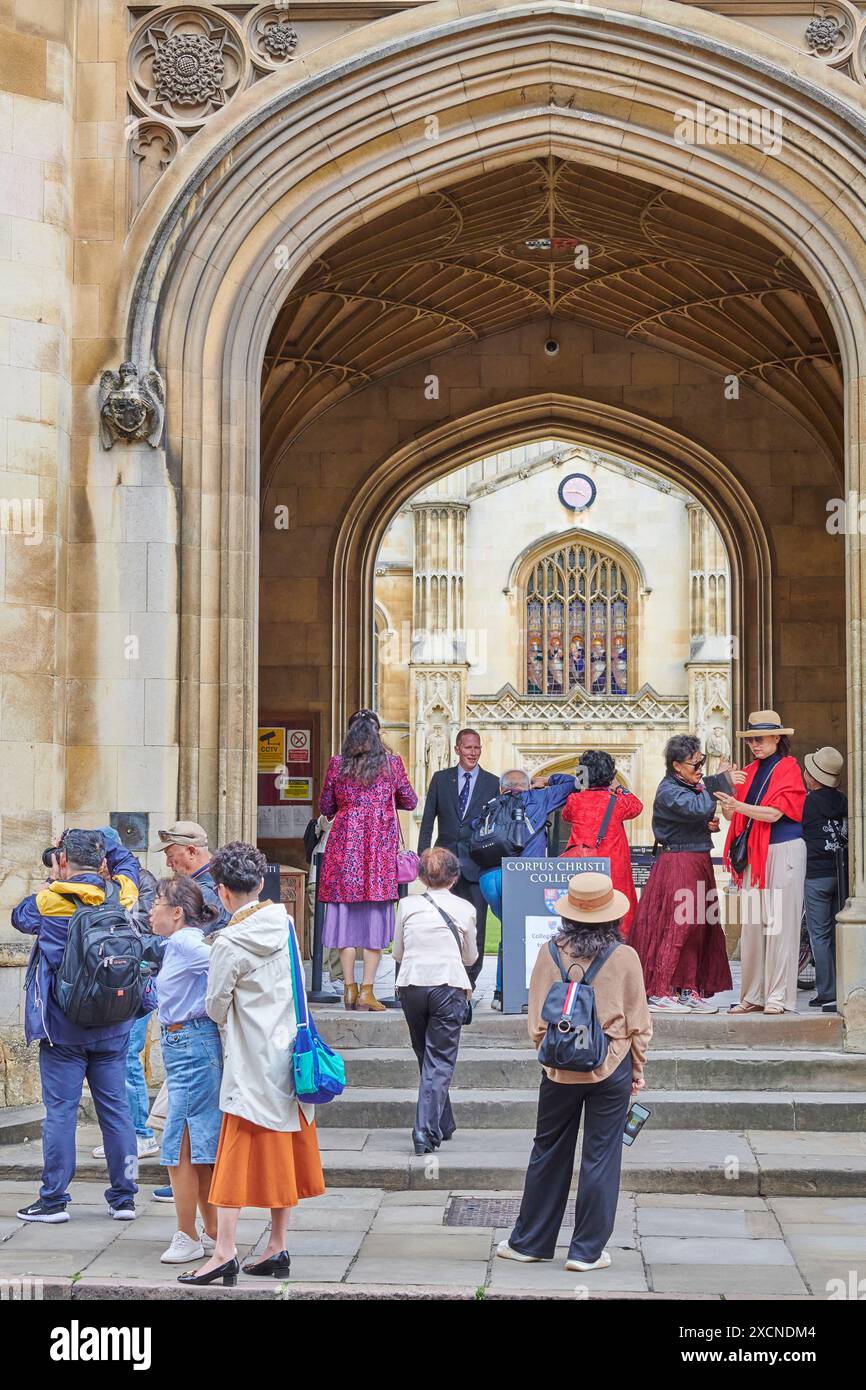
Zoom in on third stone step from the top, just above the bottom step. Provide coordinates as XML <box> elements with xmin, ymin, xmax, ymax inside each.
<box><xmin>317</xmin><ymin>1087</ymin><xmax>866</xmax><ymax>1128</ymax></box>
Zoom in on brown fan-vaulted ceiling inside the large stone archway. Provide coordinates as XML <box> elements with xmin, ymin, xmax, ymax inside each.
<box><xmin>263</xmin><ymin>157</ymin><xmax>842</xmax><ymax>457</ymax></box>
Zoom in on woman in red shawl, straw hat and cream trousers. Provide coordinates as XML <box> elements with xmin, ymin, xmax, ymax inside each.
<box><xmin>716</xmin><ymin>709</ymin><xmax>806</xmax><ymax>1013</ymax></box>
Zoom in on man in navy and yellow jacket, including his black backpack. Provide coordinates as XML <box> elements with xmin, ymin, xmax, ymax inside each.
<box><xmin>13</xmin><ymin>830</ymin><xmax>143</xmax><ymax>1225</ymax></box>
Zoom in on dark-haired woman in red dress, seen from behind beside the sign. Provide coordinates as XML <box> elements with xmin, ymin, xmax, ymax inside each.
<box><xmin>563</xmin><ymin>748</ymin><xmax>644</xmax><ymax>935</ymax></box>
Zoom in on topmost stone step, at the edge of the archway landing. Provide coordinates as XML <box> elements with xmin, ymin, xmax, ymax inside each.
<box><xmin>313</xmin><ymin>1005</ymin><xmax>842</xmax><ymax>1052</ymax></box>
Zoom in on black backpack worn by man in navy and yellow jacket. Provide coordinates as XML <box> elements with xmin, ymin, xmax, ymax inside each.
<box><xmin>54</xmin><ymin>880</ymin><xmax>145</xmax><ymax>1029</ymax></box>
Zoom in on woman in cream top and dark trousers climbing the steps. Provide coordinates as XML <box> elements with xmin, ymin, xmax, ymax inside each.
<box><xmin>393</xmin><ymin>848</ymin><xmax>478</xmax><ymax>1154</ymax></box>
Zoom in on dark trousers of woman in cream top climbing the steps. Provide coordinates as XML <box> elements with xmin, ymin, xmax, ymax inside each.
<box><xmin>400</xmin><ymin>984</ymin><xmax>466</xmax><ymax>1140</ymax></box>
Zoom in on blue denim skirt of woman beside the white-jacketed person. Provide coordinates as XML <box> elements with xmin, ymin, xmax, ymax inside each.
<box><xmin>160</xmin><ymin>1019</ymin><xmax>222</xmax><ymax>1168</ymax></box>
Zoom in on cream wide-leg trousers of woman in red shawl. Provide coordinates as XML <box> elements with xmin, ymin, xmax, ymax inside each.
<box><xmin>740</xmin><ymin>840</ymin><xmax>806</xmax><ymax>1009</ymax></box>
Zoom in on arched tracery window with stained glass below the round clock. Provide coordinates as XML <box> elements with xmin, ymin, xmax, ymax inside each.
<box><xmin>525</xmin><ymin>542</ymin><xmax>634</xmax><ymax>696</ymax></box>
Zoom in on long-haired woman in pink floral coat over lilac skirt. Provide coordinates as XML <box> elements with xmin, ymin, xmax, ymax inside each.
<box><xmin>318</xmin><ymin>709</ymin><xmax>418</xmax><ymax>1009</ymax></box>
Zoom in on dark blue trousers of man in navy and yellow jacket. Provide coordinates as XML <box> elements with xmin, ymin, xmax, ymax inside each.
<box><xmin>39</xmin><ymin>1034</ymin><xmax>138</xmax><ymax>1207</ymax></box>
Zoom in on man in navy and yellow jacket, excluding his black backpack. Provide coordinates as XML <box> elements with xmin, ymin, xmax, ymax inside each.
<box><xmin>13</xmin><ymin>830</ymin><xmax>139</xmax><ymax>1225</ymax></box>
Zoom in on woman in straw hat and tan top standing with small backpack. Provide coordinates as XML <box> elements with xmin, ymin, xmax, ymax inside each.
<box><xmin>496</xmin><ymin>873</ymin><xmax>652</xmax><ymax>1272</ymax></box>
